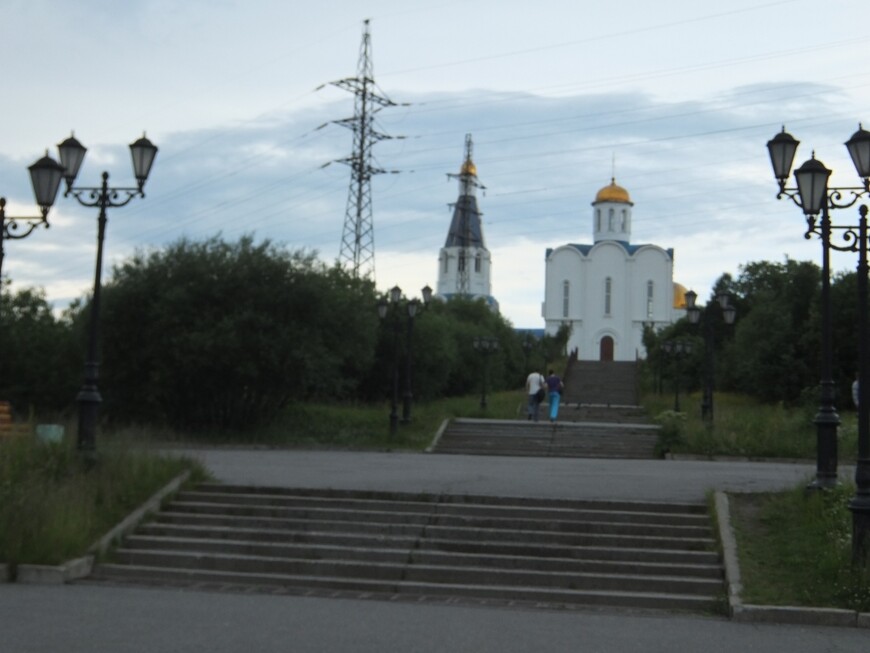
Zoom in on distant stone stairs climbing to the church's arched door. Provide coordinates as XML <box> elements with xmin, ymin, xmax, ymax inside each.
<box><xmin>429</xmin><ymin>359</ymin><xmax>660</xmax><ymax>459</ymax></box>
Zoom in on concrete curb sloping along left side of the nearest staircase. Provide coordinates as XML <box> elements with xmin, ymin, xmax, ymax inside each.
<box><xmin>13</xmin><ymin>470</ymin><xmax>190</xmax><ymax>585</ymax></box>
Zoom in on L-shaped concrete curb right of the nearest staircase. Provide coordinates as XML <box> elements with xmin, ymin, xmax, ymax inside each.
<box><xmin>714</xmin><ymin>490</ymin><xmax>870</xmax><ymax>628</ymax></box>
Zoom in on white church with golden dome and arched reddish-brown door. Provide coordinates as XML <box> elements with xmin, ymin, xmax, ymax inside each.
<box><xmin>542</xmin><ymin>179</ymin><xmax>686</xmax><ymax>361</ymax></box>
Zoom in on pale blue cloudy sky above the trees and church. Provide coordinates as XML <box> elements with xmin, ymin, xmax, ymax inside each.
<box><xmin>0</xmin><ymin>0</ymin><xmax>870</xmax><ymax>327</ymax></box>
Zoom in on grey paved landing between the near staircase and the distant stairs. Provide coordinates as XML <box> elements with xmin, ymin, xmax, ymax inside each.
<box><xmin>177</xmin><ymin>449</ymin><xmax>832</xmax><ymax>501</ymax></box>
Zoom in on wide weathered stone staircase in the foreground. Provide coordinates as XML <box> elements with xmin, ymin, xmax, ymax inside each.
<box><xmin>85</xmin><ymin>484</ymin><xmax>724</xmax><ymax>612</ymax></box>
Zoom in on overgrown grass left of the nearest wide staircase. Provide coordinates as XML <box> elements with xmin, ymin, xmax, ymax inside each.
<box><xmin>0</xmin><ymin>437</ymin><xmax>206</xmax><ymax>572</ymax></box>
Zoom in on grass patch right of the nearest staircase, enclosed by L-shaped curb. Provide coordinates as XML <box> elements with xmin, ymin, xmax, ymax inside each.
<box><xmin>730</xmin><ymin>484</ymin><xmax>870</xmax><ymax>612</ymax></box>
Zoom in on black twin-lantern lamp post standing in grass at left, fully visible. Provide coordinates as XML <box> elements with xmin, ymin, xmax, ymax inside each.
<box><xmin>57</xmin><ymin>135</ymin><xmax>157</xmax><ymax>460</ymax></box>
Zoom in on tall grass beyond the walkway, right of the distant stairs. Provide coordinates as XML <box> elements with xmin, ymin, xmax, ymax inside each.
<box><xmin>643</xmin><ymin>393</ymin><xmax>858</xmax><ymax>460</ymax></box>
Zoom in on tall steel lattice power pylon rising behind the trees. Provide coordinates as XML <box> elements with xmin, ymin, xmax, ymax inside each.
<box><xmin>332</xmin><ymin>19</ymin><xmax>396</xmax><ymax>278</ymax></box>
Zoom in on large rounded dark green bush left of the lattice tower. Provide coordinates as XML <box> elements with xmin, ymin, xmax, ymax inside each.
<box><xmin>100</xmin><ymin>236</ymin><xmax>377</xmax><ymax>431</ymax></box>
